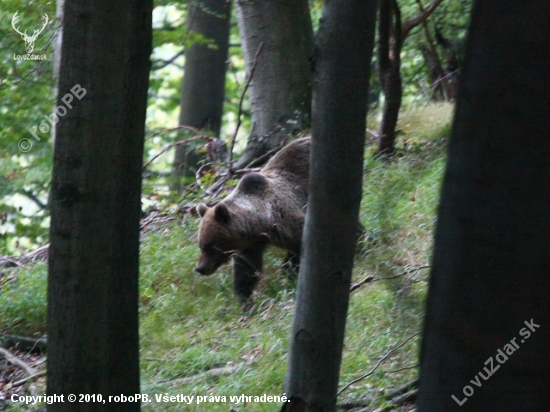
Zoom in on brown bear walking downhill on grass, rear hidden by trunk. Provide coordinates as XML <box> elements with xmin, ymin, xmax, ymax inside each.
<box><xmin>195</xmin><ymin>137</ymin><xmax>311</xmax><ymax>301</ymax></box>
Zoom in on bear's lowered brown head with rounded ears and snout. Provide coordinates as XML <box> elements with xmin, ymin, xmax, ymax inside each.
<box><xmin>195</xmin><ymin>203</ymin><xmax>232</xmax><ymax>275</ymax></box>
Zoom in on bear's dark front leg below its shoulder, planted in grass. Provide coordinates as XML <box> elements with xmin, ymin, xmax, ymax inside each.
<box><xmin>233</xmin><ymin>244</ymin><xmax>266</xmax><ymax>302</ymax></box>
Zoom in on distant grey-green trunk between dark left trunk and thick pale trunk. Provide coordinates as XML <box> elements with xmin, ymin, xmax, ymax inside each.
<box><xmin>173</xmin><ymin>0</ymin><xmax>231</xmax><ymax>190</ymax></box>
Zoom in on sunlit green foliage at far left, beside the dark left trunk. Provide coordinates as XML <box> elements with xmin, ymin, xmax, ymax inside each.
<box><xmin>0</xmin><ymin>0</ymin><xmax>57</xmax><ymax>254</ymax></box>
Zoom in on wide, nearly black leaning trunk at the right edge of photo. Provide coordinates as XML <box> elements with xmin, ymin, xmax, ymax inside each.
<box><xmin>418</xmin><ymin>0</ymin><xmax>550</xmax><ymax>412</ymax></box>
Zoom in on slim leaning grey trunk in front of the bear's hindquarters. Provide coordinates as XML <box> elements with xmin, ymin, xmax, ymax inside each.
<box><xmin>282</xmin><ymin>0</ymin><xmax>376</xmax><ymax>412</ymax></box>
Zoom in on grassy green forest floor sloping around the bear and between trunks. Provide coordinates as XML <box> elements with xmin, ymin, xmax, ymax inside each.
<box><xmin>0</xmin><ymin>104</ymin><xmax>458</xmax><ymax>412</ymax></box>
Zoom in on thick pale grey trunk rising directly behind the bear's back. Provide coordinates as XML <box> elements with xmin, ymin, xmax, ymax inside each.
<box><xmin>235</xmin><ymin>0</ymin><xmax>313</xmax><ymax>168</ymax></box>
